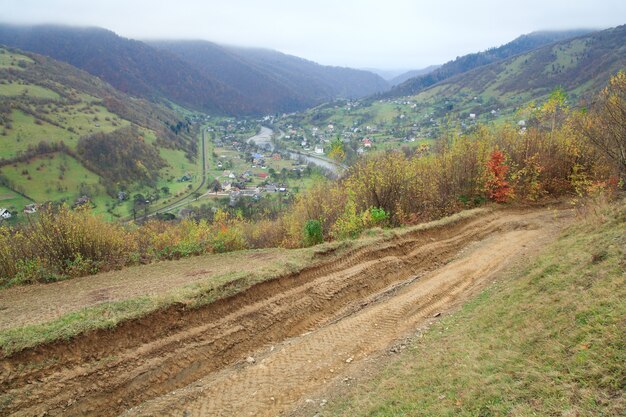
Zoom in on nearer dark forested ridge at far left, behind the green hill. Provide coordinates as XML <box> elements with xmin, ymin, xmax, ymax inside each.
<box><xmin>0</xmin><ymin>25</ymin><xmax>252</xmax><ymax>113</ymax></box>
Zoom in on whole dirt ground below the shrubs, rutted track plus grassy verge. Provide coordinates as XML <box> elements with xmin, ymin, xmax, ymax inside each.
<box><xmin>0</xmin><ymin>209</ymin><xmax>584</xmax><ymax>416</ymax></box>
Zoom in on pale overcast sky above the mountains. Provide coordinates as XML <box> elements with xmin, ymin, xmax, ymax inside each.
<box><xmin>0</xmin><ymin>0</ymin><xmax>626</xmax><ymax>69</ymax></box>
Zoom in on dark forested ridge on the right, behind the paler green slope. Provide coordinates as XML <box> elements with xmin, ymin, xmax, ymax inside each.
<box><xmin>384</xmin><ymin>29</ymin><xmax>591</xmax><ymax>97</ymax></box>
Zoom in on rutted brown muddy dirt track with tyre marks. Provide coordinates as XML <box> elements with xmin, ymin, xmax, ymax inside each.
<box><xmin>0</xmin><ymin>209</ymin><xmax>571</xmax><ymax>416</ymax></box>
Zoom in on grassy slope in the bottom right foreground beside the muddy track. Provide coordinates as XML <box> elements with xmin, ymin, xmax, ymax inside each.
<box><xmin>321</xmin><ymin>202</ymin><xmax>626</xmax><ymax>417</ymax></box>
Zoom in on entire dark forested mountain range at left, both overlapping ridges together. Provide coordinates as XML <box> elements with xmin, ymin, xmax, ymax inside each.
<box><xmin>0</xmin><ymin>25</ymin><xmax>387</xmax><ymax>115</ymax></box>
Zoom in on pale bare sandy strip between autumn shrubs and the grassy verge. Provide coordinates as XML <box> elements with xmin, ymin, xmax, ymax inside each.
<box><xmin>0</xmin><ymin>249</ymin><xmax>297</xmax><ymax>330</ymax></box>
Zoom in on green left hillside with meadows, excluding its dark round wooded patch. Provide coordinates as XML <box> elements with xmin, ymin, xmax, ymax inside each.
<box><xmin>0</xmin><ymin>48</ymin><xmax>202</xmax><ymax>220</ymax></box>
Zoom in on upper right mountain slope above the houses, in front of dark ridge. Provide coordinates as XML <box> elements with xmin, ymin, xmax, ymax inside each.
<box><xmin>416</xmin><ymin>25</ymin><xmax>626</xmax><ymax>105</ymax></box>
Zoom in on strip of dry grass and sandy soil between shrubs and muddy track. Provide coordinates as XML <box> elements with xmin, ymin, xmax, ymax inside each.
<box><xmin>0</xmin><ymin>208</ymin><xmax>492</xmax><ymax>355</ymax></box>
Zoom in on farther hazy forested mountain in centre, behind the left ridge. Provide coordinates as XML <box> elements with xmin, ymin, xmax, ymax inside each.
<box><xmin>149</xmin><ymin>41</ymin><xmax>388</xmax><ymax>111</ymax></box>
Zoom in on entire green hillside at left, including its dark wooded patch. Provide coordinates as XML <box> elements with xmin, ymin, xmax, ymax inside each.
<box><xmin>0</xmin><ymin>47</ymin><xmax>198</xmax><ymax>216</ymax></box>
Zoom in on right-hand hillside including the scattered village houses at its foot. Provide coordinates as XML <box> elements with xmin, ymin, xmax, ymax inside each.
<box><xmin>276</xmin><ymin>26</ymin><xmax>626</xmax><ymax>154</ymax></box>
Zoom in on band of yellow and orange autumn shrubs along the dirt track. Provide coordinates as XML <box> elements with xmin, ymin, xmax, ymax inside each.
<box><xmin>0</xmin><ymin>73</ymin><xmax>626</xmax><ymax>285</ymax></box>
